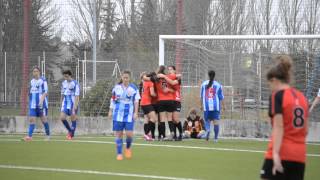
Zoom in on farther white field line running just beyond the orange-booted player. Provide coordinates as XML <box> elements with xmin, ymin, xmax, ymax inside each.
<box><xmin>0</xmin><ymin>139</ymin><xmax>320</xmax><ymax>157</ymax></box>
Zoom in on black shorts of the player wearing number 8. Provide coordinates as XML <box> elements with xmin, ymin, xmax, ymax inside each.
<box><xmin>260</xmin><ymin>159</ymin><xmax>305</xmax><ymax>180</ymax></box>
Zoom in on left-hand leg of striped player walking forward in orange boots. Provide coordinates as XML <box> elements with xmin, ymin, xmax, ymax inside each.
<box><xmin>113</xmin><ymin>121</ymin><xmax>124</xmax><ymax>160</ymax></box>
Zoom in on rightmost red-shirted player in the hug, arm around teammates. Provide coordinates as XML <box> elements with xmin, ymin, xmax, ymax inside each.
<box><xmin>158</xmin><ymin>66</ymin><xmax>182</xmax><ymax>141</ymax></box>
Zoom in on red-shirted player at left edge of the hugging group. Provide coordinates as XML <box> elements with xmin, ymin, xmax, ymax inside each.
<box><xmin>140</xmin><ymin>73</ymin><xmax>158</xmax><ymax>141</ymax></box>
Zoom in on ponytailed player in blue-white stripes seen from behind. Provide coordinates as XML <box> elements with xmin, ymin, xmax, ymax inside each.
<box><xmin>200</xmin><ymin>70</ymin><xmax>225</xmax><ymax>143</ymax></box>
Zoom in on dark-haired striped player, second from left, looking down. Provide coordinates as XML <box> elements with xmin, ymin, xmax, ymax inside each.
<box><xmin>60</xmin><ymin>70</ymin><xmax>80</xmax><ymax>140</ymax></box>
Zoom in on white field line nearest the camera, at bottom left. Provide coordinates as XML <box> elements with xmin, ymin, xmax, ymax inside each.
<box><xmin>0</xmin><ymin>165</ymin><xmax>200</xmax><ymax>180</ymax></box>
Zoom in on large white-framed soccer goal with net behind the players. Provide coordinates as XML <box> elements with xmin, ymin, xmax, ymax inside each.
<box><xmin>159</xmin><ymin>35</ymin><xmax>320</xmax><ymax>138</ymax></box>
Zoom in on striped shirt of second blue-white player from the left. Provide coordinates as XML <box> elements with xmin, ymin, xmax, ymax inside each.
<box><xmin>61</xmin><ymin>80</ymin><xmax>80</xmax><ymax>109</ymax></box>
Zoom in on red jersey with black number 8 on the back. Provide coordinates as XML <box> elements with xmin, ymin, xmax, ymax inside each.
<box><xmin>265</xmin><ymin>88</ymin><xmax>309</xmax><ymax>163</ymax></box>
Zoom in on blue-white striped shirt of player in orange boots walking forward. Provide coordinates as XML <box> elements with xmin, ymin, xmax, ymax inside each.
<box><xmin>112</xmin><ymin>83</ymin><xmax>140</xmax><ymax>122</ymax></box>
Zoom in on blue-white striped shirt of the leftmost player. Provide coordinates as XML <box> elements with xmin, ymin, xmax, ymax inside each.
<box><xmin>29</xmin><ymin>77</ymin><xmax>48</xmax><ymax>109</ymax></box>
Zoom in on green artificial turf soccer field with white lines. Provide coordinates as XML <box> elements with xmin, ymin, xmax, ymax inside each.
<box><xmin>0</xmin><ymin>135</ymin><xmax>320</xmax><ymax>180</ymax></box>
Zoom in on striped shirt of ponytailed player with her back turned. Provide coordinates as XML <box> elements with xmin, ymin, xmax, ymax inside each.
<box><xmin>200</xmin><ymin>80</ymin><xmax>224</xmax><ymax>111</ymax></box>
